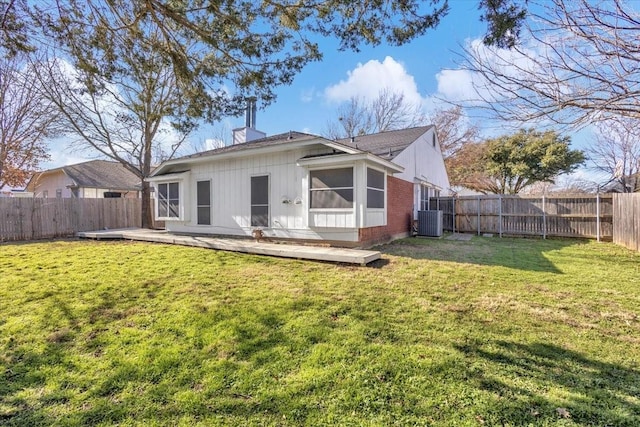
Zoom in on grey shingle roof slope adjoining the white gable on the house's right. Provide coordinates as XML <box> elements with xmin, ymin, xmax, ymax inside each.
<box><xmin>338</xmin><ymin>125</ymin><xmax>433</xmax><ymax>160</ymax></box>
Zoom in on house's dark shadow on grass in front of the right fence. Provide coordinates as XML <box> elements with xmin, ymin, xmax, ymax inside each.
<box><xmin>378</xmin><ymin>236</ymin><xmax>582</xmax><ymax>273</ymax></box>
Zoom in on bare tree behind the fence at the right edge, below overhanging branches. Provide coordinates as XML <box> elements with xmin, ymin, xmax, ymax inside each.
<box><xmin>586</xmin><ymin>118</ymin><xmax>640</xmax><ymax>193</ymax></box>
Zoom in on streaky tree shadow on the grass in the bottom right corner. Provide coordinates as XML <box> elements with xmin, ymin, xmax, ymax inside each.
<box><xmin>456</xmin><ymin>341</ymin><xmax>640</xmax><ymax>426</ymax></box>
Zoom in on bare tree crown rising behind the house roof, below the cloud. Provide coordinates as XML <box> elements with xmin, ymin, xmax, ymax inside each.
<box><xmin>323</xmin><ymin>88</ymin><xmax>425</xmax><ymax>139</ymax></box>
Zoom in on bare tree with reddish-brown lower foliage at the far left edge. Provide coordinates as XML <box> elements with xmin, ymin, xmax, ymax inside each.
<box><xmin>0</xmin><ymin>55</ymin><xmax>58</xmax><ymax>188</ymax></box>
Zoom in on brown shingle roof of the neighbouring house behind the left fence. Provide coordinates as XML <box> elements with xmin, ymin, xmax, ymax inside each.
<box><xmin>61</xmin><ymin>160</ymin><xmax>140</xmax><ymax>190</ymax></box>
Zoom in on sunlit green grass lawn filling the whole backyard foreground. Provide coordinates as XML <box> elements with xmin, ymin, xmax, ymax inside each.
<box><xmin>0</xmin><ymin>237</ymin><xmax>640</xmax><ymax>426</ymax></box>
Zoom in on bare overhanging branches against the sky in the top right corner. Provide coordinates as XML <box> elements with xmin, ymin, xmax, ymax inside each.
<box><xmin>463</xmin><ymin>0</ymin><xmax>640</xmax><ymax>126</ymax></box>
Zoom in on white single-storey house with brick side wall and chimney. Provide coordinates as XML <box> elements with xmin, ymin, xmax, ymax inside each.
<box><xmin>148</xmin><ymin>125</ymin><xmax>449</xmax><ymax>246</ymax></box>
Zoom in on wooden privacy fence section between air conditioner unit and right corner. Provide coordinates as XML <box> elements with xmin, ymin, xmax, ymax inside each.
<box><xmin>429</xmin><ymin>194</ymin><xmax>613</xmax><ymax>240</ymax></box>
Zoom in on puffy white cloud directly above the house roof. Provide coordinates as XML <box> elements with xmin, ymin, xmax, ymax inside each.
<box><xmin>324</xmin><ymin>56</ymin><xmax>423</xmax><ymax>105</ymax></box>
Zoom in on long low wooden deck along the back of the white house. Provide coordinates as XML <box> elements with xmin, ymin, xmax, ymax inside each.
<box><xmin>76</xmin><ymin>228</ymin><xmax>381</xmax><ymax>265</ymax></box>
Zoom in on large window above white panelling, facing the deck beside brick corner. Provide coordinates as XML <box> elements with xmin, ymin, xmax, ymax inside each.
<box><xmin>310</xmin><ymin>168</ymin><xmax>353</xmax><ymax>209</ymax></box>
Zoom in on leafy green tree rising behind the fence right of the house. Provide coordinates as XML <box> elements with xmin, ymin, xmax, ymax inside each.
<box><xmin>450</xmin><ymin>129</ymin><xmax>585</xmax><ymax>194</ymax></box>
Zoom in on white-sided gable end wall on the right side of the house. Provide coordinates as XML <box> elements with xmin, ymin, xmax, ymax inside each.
<box><xmin>393</xmin><ymin>128</ymin><xmax>450</xmax><ymax>218</ymax></box>
